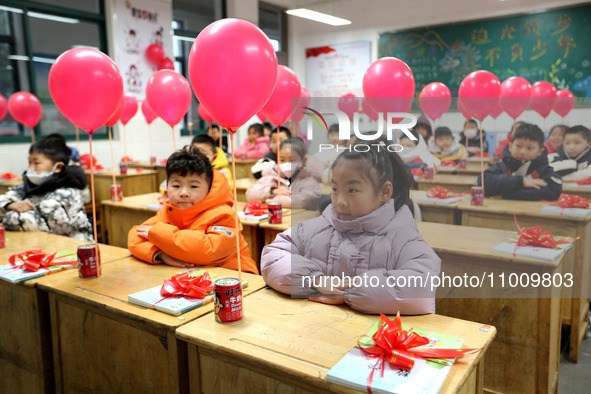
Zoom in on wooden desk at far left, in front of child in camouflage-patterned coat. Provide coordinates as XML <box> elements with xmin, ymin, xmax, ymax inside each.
<box><xmin>0</xmin><ymin>231</ymin><xmax>129</xmax><ymax>393</ymax></box>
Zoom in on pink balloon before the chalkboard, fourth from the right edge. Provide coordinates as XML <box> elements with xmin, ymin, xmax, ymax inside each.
<box><xmin>458</xmin><ymin>70</ymin><xmax>501</xmax><ymax>120</ymax></box>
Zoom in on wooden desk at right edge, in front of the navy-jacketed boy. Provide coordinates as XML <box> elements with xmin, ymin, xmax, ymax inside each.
<box><xmin>457</xmin><ymin>198</ymin><xmax>591</xmax><ymax>361</ymax></box>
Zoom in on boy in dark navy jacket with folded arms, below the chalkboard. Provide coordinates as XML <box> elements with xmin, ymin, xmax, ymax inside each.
<box><xmin>477</xmin><ymin>123</ymin><xmax>562</xmax><ymax>201</ymax></box>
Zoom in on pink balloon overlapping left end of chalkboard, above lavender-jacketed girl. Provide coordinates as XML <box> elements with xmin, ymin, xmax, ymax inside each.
<box><xmin>363</xmin><ymin>57</ymin><xmax>415</xmax><ymax>116</ymax></box>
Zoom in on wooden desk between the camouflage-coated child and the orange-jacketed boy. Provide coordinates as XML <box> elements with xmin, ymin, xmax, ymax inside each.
<box><xmin>85</xmin><ymin>169</ymin><xmax>159</xmax><ymax>201</ymax></box>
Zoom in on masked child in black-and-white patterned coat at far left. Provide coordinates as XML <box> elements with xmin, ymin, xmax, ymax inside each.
<box><xmin>0</xmin><ymin>137</ymin><xmax>93</xmax><ymax>242</ymax></box>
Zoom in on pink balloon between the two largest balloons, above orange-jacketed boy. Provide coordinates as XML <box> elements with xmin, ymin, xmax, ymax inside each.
<box><xmin>146</xmin><ymin>70</ymin><xmax>192</xmax><ymax>127</ymax></box>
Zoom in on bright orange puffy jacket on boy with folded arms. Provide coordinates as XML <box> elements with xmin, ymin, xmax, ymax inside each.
<box><xmin>127</xmin><ymin>171</ymin><xmax>259</xmax><ymax>274</ymax></box>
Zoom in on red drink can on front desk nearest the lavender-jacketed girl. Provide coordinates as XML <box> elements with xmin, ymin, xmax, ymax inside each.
<box><xmin>213</xmin><ymin>278</ymin><xmax>242</xmax><ymax>324</ymax></box>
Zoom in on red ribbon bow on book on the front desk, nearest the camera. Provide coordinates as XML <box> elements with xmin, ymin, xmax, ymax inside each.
<box><xmin>357</xmin><ymin>313</ymin><xmax>480</xmax><ymax>393</ymax></box>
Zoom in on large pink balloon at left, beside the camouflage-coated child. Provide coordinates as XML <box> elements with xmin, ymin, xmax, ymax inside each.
<box><xmin>49</xmin><ymin>48</ymin><xmax>123</xmax><ymax>134</ymax></box>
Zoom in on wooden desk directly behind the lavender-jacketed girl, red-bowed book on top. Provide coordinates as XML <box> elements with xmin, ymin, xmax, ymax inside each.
<box><xmin>417</xmin><ymin>222</ymin><xmax>573</xmax><ymax>393</ymax></box>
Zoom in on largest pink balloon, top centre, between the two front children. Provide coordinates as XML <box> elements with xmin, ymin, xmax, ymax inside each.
<box><xmin>189</xmin><ymin>18</ymin><xmax>280</xmax><ymax>133</ymax></box>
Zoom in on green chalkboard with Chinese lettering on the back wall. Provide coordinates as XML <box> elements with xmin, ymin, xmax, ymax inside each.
<box><xmin>378</xmin><ymin>5</ymin><xmax>591</xmax><ymax>101</ymax></box>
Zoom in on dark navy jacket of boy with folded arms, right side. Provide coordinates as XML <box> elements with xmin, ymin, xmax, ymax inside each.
<box><xmin>477</xmin><ymin>147</ymin><xmax>562</xmax><ymax>201</ymax></box>
